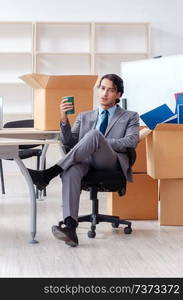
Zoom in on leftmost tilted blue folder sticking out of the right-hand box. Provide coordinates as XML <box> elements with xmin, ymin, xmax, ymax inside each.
<box><xmin>140</xmin><ymin>104</ymin><xmax>174</xmax><ymax>129</ymax></box>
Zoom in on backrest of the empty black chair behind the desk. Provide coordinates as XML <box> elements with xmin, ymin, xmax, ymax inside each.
<box><xmin>3</xmin><ymin>119</ymin><xmax>40</xmax><ymax>149</ymax></box>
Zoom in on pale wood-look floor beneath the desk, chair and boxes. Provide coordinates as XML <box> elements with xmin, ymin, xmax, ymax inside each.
<box><xmin>0</xmin><ymin>169</ymin><xmax>183</xmax><ymax>278</ymax></box>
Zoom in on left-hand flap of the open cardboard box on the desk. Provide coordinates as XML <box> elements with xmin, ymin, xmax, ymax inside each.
<box><xmin>19</xmin><ymin>73</ymin><xmax>50</xmax><ymax>88</ymax></box>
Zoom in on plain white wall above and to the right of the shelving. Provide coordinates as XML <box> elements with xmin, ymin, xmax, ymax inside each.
<box><xmin>0</xmin><ymin>0</ymin><xmax>183</xmax><ymax>56</ymax></box>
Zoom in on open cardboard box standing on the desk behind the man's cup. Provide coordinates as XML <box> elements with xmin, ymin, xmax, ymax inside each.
<box><xmin>20</xmin><ymin>73</ymin><xmax>98</xmax><ymax>130</ymax></box>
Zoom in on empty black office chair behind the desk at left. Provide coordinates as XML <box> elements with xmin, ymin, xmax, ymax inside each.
<box><xmin>0</xmin><ymin>119</ymin><xmax>46</xmax><ymax>198</ymax></box>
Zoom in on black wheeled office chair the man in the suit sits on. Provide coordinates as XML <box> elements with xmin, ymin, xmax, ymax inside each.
<box><xmin>61</xmin><ymin>148</ymin><xmax>136</xmax><ymax>238</ymax></box>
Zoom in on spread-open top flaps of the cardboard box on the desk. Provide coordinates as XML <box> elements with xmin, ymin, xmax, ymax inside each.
<box><xmin>20</xmin><ymin>73</ymin><xmax>98</xmax><ymax>89</ymax></box>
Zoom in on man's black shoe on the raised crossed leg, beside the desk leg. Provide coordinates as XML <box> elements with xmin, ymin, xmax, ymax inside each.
<box><xmin>27</xmin><ymin>169</ymin><xmax>49</xmax><ymax>191</ymax></box>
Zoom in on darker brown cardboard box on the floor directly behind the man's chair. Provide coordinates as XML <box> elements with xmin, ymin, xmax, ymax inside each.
<box><xmin>107</xmin><ymin>174</ymin><xmax>158</xmax><ymax>220</ymax></box>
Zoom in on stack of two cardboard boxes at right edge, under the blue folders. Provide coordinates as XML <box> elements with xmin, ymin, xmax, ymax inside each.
<box><xmin>146</xmin><ymin>124</ymin><xmax>183</xmax><ymax>225</ymax></box>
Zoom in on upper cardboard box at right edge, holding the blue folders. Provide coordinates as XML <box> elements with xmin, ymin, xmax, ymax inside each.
<box><xmin>146</xmin><ymin>124</ymin><xmax>183</xmax><ymax>179</ymax></box>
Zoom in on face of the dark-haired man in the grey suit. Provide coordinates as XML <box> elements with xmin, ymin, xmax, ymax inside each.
<box><xmin>99</xmin><ymin>78</ymin><xmax>121</xmax><ymax>109</ymax></box>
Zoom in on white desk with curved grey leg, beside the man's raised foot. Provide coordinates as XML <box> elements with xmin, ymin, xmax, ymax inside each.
<box><xmin>0</xmin><ymin>128</ymin><xmax>62</xmax><ymax>244</ymax></box>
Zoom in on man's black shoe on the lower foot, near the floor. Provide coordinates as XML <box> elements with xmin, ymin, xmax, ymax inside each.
<box><xmin>52</xmin><ymin>225</ymin><xmax>79</xmax><ymax>247</ymax></box>
